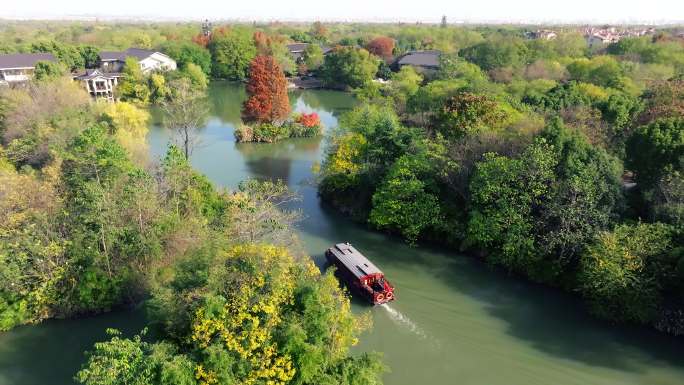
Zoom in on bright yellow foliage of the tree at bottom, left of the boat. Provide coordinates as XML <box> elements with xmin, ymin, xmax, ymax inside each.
<box><xmin>190</xmin><ymin>244</ymin><xmax>295</xmax><ymax>385</ymax></box>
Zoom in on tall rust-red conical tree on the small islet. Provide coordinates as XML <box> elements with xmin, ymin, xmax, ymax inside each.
<box><xmin>242</xmin><ymin>55</ymin><xmax>290</xmax><ymax>123</ymax></box>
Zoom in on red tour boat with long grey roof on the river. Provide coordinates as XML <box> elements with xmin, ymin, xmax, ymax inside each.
<box><xmin>325</xmin><ymin>243</ymin><xmax>394</xmax><ymax>305</ymax></box>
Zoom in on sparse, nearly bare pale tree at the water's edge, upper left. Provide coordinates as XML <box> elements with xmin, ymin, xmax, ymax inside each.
<box><xmin>161</xmin><ymin>78</ymin><xmax>208</xmax><ymax>159</ymax></box>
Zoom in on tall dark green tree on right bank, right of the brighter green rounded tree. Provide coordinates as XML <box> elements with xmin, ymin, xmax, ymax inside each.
<box><xmin>535</xmin><ymin>119</ymin><xmax>623</xmax><ymax>276</ymax></box>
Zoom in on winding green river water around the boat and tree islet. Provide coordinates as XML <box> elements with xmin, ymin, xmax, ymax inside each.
<box><xmin>0</xmin><ymin>82</ymin><xmax>684</xmax><ymax>385</ymax></box>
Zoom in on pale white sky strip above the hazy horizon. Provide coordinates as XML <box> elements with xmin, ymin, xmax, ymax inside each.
<box><xmin>0</xmin><ymin>0</ymin><xmax>684</xmax><ymax>24</ymax></box>
